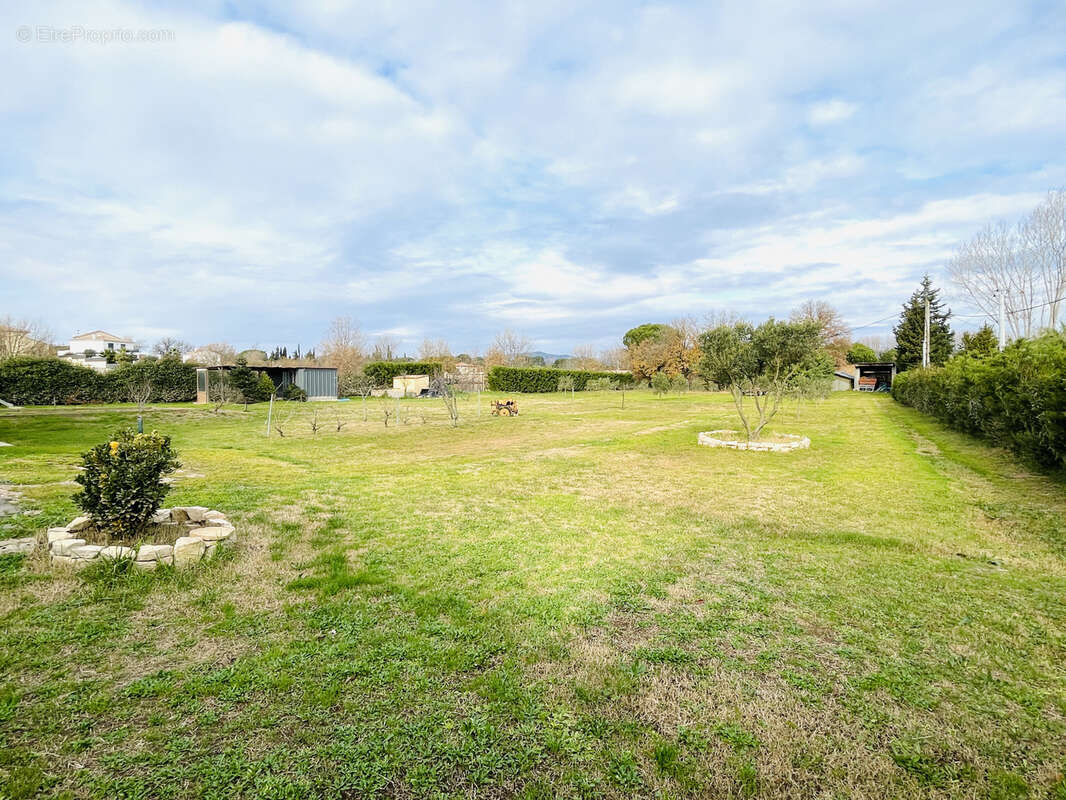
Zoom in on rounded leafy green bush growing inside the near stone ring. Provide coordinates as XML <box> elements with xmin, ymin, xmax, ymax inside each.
<box><xmin>74</xmin><ymin>429</ymin><xmax>181</xmax><ymax>538</ymax></box>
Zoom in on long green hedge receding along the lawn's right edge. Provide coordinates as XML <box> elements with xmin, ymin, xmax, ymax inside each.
<box><xmin>892</xmin><ymin>333</ymin><xmax>1066</xmax><ymax>469</ymax></box>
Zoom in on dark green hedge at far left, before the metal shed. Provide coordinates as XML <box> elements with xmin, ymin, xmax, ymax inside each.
<box><xmin>0</xmin><ymin>357</ymin><xmax>196</xmax><ymax>405</ymax></box>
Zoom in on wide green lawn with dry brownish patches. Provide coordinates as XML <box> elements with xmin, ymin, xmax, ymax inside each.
<box><xmin>0</xmin><ymin>393</ymin><xmax>1066</xmax><ymax>798</ymax></box>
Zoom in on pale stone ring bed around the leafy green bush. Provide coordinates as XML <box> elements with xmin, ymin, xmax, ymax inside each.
<box><xmin>48</xmin><ymin>506</ymin><xmax>236</xmax><ymax>570</ymax></box>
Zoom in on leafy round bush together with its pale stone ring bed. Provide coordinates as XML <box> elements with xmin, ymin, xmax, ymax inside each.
<box><xmin>48</xmin><ymin>430</ymin><xmax>235</xmax><ymax>576</ymax></box>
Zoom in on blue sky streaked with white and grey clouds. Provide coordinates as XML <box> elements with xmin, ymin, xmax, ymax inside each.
<box><xmin>0</xmin><ymin>0</ymin><xmax>1066</xmax><ymax>353</ymax></box>
